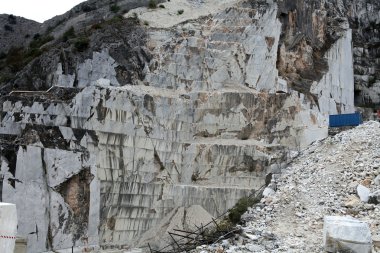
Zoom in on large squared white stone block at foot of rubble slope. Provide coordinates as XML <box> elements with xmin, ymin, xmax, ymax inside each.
<box><xmin>323</xmin><ymin>216</ymin><xmax>372</xmax><ymax>253</ymax></box>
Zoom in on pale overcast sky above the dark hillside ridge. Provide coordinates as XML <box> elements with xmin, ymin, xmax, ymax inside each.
<box><xmin>0</xmin><ymin>0</ymin><xmax>85</xmax><ymax>23</ymax></box>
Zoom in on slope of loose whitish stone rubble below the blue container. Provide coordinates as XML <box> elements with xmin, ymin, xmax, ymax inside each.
<box><xmin>197</xmin><ymin>121</ymin><xmax>380</xmax><ymax>252</ymax></box>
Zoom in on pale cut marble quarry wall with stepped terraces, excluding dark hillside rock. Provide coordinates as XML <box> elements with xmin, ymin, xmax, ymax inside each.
<box><xmin>0</xmin><ymin>0</ymin><xmax>353</xmax><ymax>252</ymax></box>
